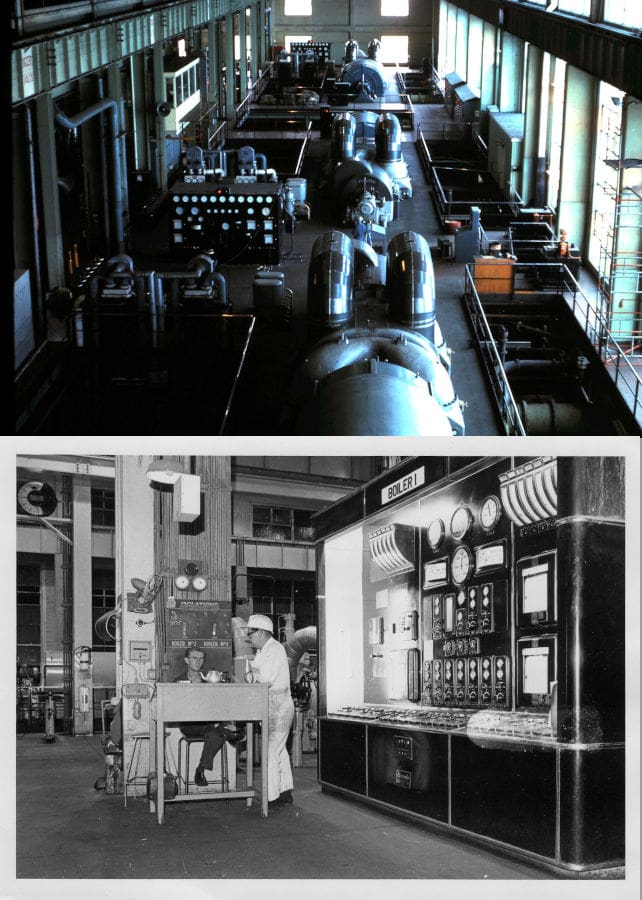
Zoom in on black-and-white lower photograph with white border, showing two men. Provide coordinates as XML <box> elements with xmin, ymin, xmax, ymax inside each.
<box><xmin>3</xmin><ymin>438</ymin><xmax>639</xmax><ymax>898</ymax></box>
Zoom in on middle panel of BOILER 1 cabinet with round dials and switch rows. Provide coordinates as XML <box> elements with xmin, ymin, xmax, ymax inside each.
<box><xmin>420</xmin><ymin>461</ymin><xmax>511</xmax><ymax>708</ymax></box>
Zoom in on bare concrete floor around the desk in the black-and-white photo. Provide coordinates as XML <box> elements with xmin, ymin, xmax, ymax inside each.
<box><xmin>12</xmin><ymin>734</ymin><xmax>556</xmax><ymax>888</ymax></box>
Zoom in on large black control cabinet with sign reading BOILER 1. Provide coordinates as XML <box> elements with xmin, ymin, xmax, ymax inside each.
<box><xmin>315</xmin><ymin>456</ymin><xmax>625</xmax><ymax>872</ymax></box>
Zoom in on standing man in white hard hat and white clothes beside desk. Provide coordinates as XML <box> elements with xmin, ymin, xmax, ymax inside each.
<box><xmin>246</xmin><ymin>615</ymin><xmax>294</xmax><ymax>808</ymax></box>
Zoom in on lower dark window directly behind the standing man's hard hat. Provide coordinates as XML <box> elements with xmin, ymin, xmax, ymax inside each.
<box><xmin>251</xmin><ymin>573</ymin><xmax>317</xmax><ymax>631</ymax></box>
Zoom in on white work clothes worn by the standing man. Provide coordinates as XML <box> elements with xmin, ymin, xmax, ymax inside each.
<box><xmin>250</xmin><ymin>638</ymin><xmax>294</xmax><ymax>800</ymax></box>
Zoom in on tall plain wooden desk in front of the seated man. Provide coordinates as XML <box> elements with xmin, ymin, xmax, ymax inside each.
<box><xmin>149</xmin><ymin>682</ymin><xmax>268</xmax><ymax>825</ymax></box>
